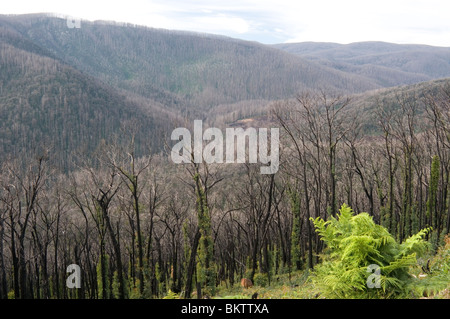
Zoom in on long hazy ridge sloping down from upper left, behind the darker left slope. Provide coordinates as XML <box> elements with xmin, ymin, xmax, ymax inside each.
<box><xmin>0</xmin><ymin>15</ymin><xmax>384</xmax><ymax>114</ymax></box>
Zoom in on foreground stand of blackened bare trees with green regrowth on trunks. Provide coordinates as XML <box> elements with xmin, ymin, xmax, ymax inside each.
<box><xmin>0</xmin><ymin>80</ymin><xmax>450</xmax><ymax>298</ymax></box>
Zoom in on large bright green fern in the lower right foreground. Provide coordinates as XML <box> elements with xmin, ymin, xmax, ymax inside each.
<box><xmin>312</xmin><ymin>204</ymin><xmax>429</xmax><ymax>298</ymax></box>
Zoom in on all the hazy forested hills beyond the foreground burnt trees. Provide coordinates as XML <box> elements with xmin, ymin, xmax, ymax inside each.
<box><xmin>0</xmin><ymin>14</ymin><xmax>450</xmax><ymax>169</ymax></box>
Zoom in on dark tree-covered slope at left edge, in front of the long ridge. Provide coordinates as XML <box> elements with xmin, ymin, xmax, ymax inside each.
<box><xmin>0</xmin><ymin>23</ymin><xmax>175</xmax><ymax>170</ymax></box>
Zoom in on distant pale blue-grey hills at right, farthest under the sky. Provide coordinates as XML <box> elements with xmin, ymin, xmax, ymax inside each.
<box><xmin>274</xmin><ymin>42</ymin><xmax>450</xmax><ymax>87</ymax></box>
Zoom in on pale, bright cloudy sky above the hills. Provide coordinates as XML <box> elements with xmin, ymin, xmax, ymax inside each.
<box><xmin>0</xmin><ymin>0</ymin><xmax>450</xmax><ymax>47</ymax></box>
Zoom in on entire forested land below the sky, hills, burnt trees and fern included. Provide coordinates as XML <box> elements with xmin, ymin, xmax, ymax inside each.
<box><xmin>0</xmin><ymin>15</ymin><xmax>450</xmax><ymax>299</ymax></box>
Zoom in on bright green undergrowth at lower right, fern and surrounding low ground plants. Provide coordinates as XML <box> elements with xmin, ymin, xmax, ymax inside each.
<box><xmin>171</xmin><ymin>204</ymin><xmax>450</xmax><ymax>299</ymax></box>
